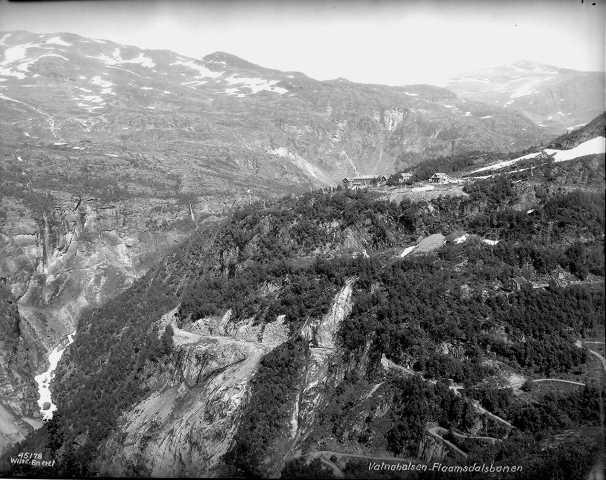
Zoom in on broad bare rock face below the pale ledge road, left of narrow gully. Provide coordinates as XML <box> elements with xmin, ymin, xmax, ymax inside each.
<box><xmin>99</xmin><ymin>307</ymin><xmax>288</xmax><ymax>476</ymax></box>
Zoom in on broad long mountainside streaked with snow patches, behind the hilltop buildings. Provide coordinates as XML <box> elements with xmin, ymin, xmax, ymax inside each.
<box><xmin>0</xmin><ymin>32</ymin><xmax>544</xmax><ymax>199</ymax></box>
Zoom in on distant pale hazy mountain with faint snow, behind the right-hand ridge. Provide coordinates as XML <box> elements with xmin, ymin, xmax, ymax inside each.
<box><xmin>447</xmin><ymin>61</ymin><xmax>604</xmax><ymax>134</ymax></box>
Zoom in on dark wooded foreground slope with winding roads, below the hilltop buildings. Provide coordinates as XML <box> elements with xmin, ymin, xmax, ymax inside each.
<box><xmin>3</xmin><ymin>129</ymin><xmax>604</xmax><ymax>479</ymax></box>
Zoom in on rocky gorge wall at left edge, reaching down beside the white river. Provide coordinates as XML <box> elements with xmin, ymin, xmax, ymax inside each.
<box><xmin>0</xmin><ymin>196</ymin><xmax>192</xmax><ymax>456</ymax></box>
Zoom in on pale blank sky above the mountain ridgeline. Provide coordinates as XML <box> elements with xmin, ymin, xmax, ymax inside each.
<box><xmin>0</xmin><ymin>0</ymin><xmax>606</xmax><ymax>85</ymax></box>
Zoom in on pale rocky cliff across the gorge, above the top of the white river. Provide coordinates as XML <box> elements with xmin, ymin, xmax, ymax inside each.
<box><xmin>0</xmin><ymin>194</ymin><xmax>191</xmax><ymax>344</ymax></box>
